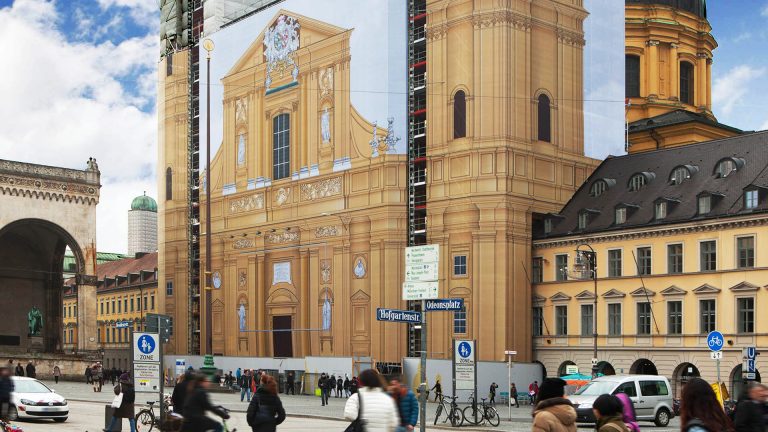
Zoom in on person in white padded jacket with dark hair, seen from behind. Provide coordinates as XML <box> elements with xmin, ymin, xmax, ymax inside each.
<box><xmin>344</xmin><ymin>369</ymin><xmax>400</xmax><ymax>432</ymax></box>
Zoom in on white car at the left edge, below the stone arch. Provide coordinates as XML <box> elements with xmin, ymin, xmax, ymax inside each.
<box><xmin>9</xmin><ymin>376</ymin><xmax>69</xmax><ymax>423</ymax></box>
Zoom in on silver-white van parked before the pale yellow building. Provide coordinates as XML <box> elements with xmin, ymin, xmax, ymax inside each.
<box><xmin>568</xmin><ymin>375</ymin><xmax>675</xmax><ymax>427</ymax></box>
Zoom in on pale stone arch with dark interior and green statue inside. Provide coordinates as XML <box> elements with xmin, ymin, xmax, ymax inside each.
<box><xmin>0</xmin><ymin>158</ymin><xmax>101</xmax><ymax>353</ymax></box>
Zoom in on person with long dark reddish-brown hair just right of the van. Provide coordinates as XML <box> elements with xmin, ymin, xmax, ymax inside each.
<box><xmin>680</xmin><ymin>378</ymin><xmax>738</xmax><ymax>432</ymax></box>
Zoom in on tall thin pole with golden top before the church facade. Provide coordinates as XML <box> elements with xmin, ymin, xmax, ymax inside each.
<box><xmin>203</xmin><ymin>39</ymin><xmax>213</xmax><ymax>354</ymax></box>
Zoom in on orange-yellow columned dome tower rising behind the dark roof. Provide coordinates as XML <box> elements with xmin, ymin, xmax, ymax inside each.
<box><xmin>625</xmin><ymin>0</ymin><xmax>741</xmax><ymax>153</ymax></box>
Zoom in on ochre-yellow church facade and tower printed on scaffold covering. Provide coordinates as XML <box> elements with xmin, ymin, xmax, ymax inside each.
<box><xmin>158</xmin><ymin>0</ymin><xmax>597</xmax><ymax>362</ymax></box>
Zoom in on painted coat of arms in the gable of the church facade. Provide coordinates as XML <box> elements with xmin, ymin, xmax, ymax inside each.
<box><xmin>264</xmin><ymin>15</ymin><xmax>300</xmax><ymax>90</ymax></box>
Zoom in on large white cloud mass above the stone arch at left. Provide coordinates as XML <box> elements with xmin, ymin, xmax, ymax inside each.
<box><xmin>0</xmin><ymin>0</ymin><xmax>158</xmax><ymax>252</ymax></box>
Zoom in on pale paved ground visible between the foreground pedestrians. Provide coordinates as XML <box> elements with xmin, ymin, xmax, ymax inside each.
<box><xmin>10</xmin><ymin>381</ymin><xmax>680</xmax><ymax>432</ymax></box>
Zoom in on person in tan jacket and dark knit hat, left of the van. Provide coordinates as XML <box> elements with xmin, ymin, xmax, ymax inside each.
<box><xmin>531</xmin><ymin>378</ymin><xmax>576</xmax><ymax>432</ymax></box>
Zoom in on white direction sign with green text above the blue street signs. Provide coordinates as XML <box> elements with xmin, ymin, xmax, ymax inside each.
<box><xmin>403</xmin><ymin>245</ymin><xmax>440</xmax><ymax>300</ymax></box>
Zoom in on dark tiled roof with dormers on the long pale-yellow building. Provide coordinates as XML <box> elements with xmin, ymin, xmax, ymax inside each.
<box><xmin>534</xmin><ymin>131</ymin><xmax>768</xmax><ymax>239</ymax></box>
